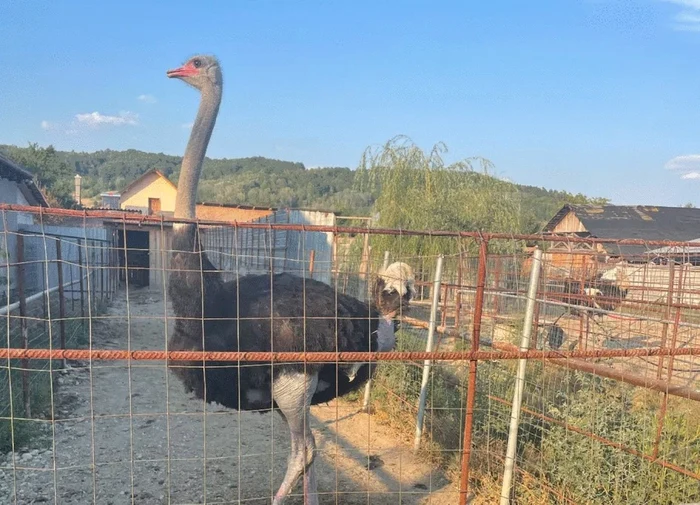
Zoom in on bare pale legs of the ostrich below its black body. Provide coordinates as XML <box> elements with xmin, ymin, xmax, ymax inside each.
<box><xmin>272</xmin><ymin>372</ymin><xmax>318</xmax><ymax>505</ymax></box>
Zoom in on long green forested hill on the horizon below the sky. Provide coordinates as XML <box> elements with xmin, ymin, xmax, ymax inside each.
<box><xmin>0</xmin><ymin>141</ymin><xmax>600</xmax><ymax>231</ymax></box>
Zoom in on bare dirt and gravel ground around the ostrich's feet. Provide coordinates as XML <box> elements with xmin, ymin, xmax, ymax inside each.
<box><xmin>0</xmin><ymin>290</ymin><xmax>458</xmax><ymax>505</ymax></box>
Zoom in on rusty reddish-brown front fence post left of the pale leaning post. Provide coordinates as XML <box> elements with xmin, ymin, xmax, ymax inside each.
<box><xmin>459</xmin><ymin>238</ymin><xmax>489</xmax><ymax>505</ymax></box>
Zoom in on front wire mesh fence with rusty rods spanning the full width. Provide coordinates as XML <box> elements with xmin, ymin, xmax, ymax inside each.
<box><xmin>0</xmin><ymin>206</ymin><xmax>700</xmax><ymax>504</ymax></box>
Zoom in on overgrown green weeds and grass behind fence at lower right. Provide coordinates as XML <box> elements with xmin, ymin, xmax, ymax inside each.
<box><xmin>352</xmin><ymin>324</ymin><xmax>700</xmax><ymax>505</ymax></box>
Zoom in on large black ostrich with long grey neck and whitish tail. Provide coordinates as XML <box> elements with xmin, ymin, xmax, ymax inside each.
<box><xmin>167</xmin><ymin>56</ymin><xmax>415</xmax><ymax>505</ymax></box>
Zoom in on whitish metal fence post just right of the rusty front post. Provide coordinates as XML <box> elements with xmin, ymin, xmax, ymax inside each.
<box><xmin>501</xmin><ymin>248</ymin><xmax>542</xmax><ymax>505</ymax></box>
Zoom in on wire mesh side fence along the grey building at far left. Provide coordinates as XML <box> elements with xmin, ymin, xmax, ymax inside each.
<box><xmin>0</xmin><ymin>209</ymin><xmax>117</xmax><ymax>460</ymax></box>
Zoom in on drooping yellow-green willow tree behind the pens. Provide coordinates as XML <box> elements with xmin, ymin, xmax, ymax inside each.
<box><xmin>355</xmin><ymin>136</ymin><xmax>523</xmax><ymax>262</ymax></box>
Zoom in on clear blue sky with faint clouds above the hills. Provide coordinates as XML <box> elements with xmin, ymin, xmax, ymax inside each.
<box><xmin>0</xmin><ymin>0</ymin><xmax>700</xmax><ymax>206</ymax></box>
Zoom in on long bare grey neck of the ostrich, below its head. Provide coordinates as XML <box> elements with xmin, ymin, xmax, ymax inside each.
<box><xmin>175</xmin><ymin>85</ymin><xmax>221</xmax><ymax>219</ymax></box>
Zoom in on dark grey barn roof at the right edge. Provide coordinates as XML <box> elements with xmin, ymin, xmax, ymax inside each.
<box><xmin>543</xmin><ymin>205</ymin><xmax>700</xmax><ymax>255</ymax></box>
